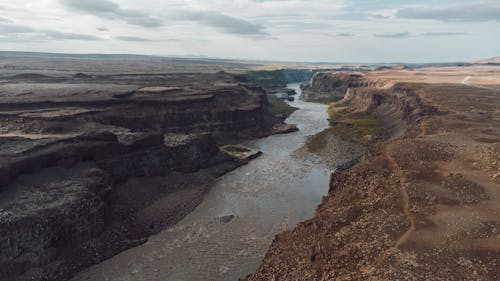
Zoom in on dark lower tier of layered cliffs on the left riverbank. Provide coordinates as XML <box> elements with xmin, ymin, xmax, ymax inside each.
<box><xmin>0</xmin><ymin>130</ymin><xmax>230</xmax><ymax>279</ymax></box>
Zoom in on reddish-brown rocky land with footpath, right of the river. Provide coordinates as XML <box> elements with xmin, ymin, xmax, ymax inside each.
<box><xmin>246</xmin><ymin>64</ymin><xmax>500</xmax><ymax>280</ymax></box>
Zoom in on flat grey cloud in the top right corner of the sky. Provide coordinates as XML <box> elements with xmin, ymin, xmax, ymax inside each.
<box><xmin>396</xmin><ymin>2</ymin><xmax>500</xmax><ymax>22</ymax></box>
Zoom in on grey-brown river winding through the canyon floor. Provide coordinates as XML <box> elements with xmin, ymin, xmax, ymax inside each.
<box><xmin>69</xmin><ymin>83</ymin><xmax>331</xmax><ymax>281</ymax></box>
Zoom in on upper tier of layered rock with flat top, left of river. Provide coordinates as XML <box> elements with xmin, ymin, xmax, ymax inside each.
<box><xmin>0</xmin><ymin>73</ymin><xmax>267</xmax><ymax>139</ymax></box>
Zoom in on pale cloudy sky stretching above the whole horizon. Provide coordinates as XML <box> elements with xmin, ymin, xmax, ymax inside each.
<box><xmin>0</xmin><ymin>0</ymin><xmax>500</xmax><ymax>62</ymax></box>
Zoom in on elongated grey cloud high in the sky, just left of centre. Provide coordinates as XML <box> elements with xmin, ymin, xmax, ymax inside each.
<box><xmin>176</xmin><ymin>11</ymin><xmax>270</xmax><ymax>39</ymax></box>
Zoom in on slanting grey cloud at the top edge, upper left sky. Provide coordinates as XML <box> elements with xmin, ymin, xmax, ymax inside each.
<box><xmin>60</xmin><ymin>0</ymin><xmax>163</xmax><ymax>27</ymax></box>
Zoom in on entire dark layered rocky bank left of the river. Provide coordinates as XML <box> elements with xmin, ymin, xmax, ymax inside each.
<box><xmin>0</xmin><ymin>58</ymin><xmax>295</xmax><ymax>280</ymax></box>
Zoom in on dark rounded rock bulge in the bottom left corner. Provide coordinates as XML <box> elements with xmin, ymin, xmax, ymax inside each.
<box><xmin>0</xmin><ymin>163</ymin><xmax>111</xmax><ymax>280</ymax></box>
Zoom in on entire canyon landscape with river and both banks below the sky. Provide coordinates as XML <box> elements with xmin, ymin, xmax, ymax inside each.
<box><xmin>0</xmin><ymin>53</ymin><xmax>500</xmax><ymax>281</ymax></box>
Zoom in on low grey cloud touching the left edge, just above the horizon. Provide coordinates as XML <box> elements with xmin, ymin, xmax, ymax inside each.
<box><xmin>0</xmin><ymin>23</ymin><xmax>102</xmax><ymax>41</ymax></box>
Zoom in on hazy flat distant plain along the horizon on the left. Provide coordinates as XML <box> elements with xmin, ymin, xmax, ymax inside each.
<box><xmin>0</xmin><ymin>51</ymin><xmax>264</xmax><ymax>75</ymax></box>
